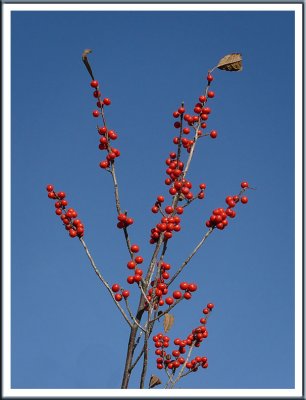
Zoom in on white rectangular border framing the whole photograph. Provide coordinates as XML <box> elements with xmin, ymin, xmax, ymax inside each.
<box><xmin>2</xmin><ymin>3</ymin><xmax>303</xmax><ymax>398</ymax></box>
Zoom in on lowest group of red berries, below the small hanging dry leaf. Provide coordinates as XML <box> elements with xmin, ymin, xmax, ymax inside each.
<box><xmin>152</xmin><ymin>303</ymin><xmax>214</xmax><ymax>371</ymax></box>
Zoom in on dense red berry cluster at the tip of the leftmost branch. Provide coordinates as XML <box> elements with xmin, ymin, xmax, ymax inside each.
<box><xmin>46</xmin><ymin>185</ymin><xmax>85</xmax><ymax>238</ymax></box>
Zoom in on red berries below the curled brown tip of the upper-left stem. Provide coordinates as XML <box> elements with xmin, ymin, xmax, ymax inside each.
<box><xmin>90</xmin><ymin>80</ymin><xmax>120</xmax><ymax>169</ymax></box>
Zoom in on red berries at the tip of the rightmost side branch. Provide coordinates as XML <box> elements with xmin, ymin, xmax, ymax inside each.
<box><xmin>206</xmin><ymin>182</ymin><xmax>249</xmax><ymax>230</ymax></box>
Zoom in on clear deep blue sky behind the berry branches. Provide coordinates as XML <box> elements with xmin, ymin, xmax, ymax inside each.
<box><xmin>12</xmin><ymin>12</ymin><xmax>294</xmax><ymax>389</ymax></box>
